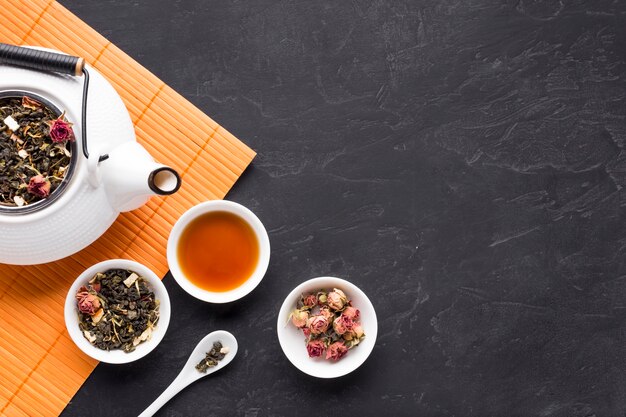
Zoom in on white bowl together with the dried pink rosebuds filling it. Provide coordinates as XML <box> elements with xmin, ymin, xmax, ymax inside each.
<box><xmin>277</xmin><ymin>277</ymin><xmax>378</xmax><ymax>378</ymax></box>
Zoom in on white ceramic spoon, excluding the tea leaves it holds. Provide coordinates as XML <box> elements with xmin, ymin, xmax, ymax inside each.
<box><xmin>139</xmin><ymin>330</ymin><xmax>237</xmax><ymax>417</ymax></box>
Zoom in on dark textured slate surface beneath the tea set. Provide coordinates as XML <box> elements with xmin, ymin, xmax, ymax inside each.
<box><xmin>61</xmin><ymin>0</ymin><xmax>626</xmax><ymax>417</ymax></box>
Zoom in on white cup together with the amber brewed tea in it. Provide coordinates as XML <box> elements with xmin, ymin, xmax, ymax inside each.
<box><xmin>167</xmin><ymin>200</ymin><xmax>270</xmax><ymax>303</ymax></box>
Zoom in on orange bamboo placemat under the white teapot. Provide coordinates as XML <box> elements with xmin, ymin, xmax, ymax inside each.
<box><xmin>0</xmin><ymin>0</ymin><xmax>255</xmax><ymax>416</ymax></box>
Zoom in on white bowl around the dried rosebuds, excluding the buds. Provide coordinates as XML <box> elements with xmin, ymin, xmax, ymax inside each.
<box><xmin>276</xmin><ymin>277</ymin><xmax>378</xmax><ymax>378</ymax></box>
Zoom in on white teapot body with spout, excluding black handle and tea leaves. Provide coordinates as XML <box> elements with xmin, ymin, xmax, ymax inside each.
<box><xmin>0</xmin><ymin>48</ymin><xmax>181</xmax><ymax>265</ymax></box>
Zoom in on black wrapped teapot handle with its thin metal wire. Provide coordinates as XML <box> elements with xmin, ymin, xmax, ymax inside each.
<box><xmin>0</xmin><ymin>43</ymin><xmax>109</xmax><ymax>162</ymax></box>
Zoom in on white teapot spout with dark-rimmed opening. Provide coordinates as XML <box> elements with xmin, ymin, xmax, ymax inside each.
<box><xmin>99</xmin><ymin>141</ymin><xmax>181</xmax><ymax>212</ymax></box>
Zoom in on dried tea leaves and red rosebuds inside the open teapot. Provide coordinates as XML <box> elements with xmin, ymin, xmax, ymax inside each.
<box><xmin>0</xmin><ymin>96</ymin><xmax>75</xmax><ymax>206</ymax></box>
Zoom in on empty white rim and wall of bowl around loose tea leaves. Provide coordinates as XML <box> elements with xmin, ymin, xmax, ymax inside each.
<box><xmin>65</xmin><ymin>259</ymin><xmax>171</xmax><ymax>364</ymax></box>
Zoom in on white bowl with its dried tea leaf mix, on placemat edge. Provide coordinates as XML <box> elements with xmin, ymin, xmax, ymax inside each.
<box><xmin>65</xmin><ymin>259</ymin><xmax>171</xmax><ymax>364</ymax></box>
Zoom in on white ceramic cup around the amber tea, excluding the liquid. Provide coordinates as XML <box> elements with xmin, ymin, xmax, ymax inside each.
<box><xmin>167</xmin><ymin>200</ymin><xmax>270</xmax><ymax>303</ymax></box>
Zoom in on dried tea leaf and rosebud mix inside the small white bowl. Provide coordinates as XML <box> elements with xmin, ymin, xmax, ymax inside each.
<box><xmin>76</xmin><ymin>269</ymin><xmax>159</xmax><ymax>352</ymax></box>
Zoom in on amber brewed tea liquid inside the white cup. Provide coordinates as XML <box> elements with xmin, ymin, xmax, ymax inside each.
<box><xmin>177</xmin><ymin>211</ymin><xmax>259</xmax><ymax>292</ymax></box>
